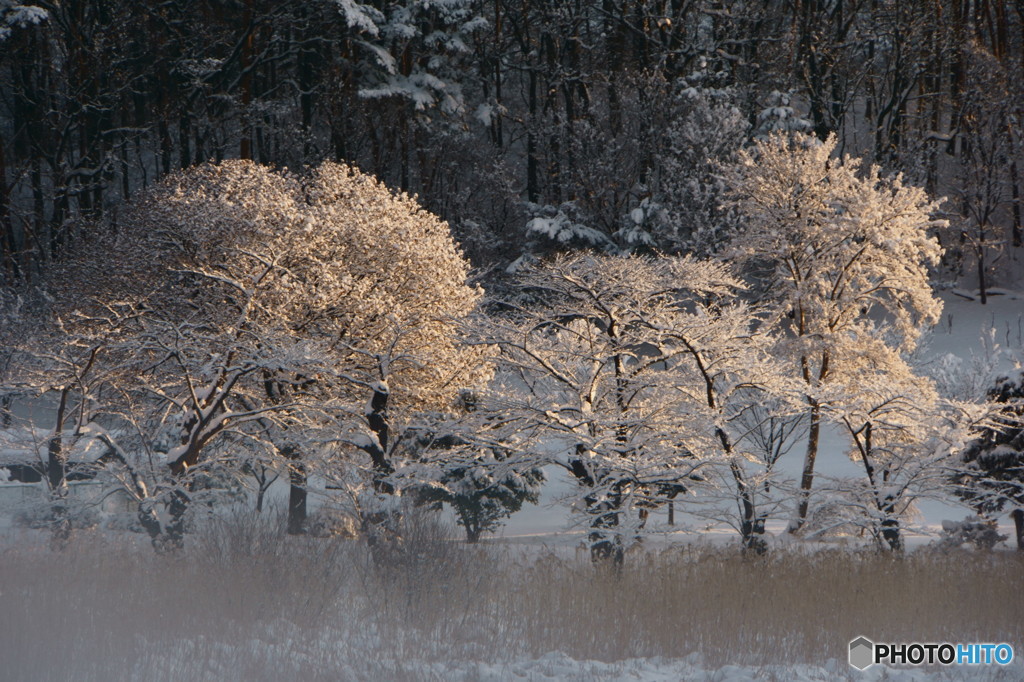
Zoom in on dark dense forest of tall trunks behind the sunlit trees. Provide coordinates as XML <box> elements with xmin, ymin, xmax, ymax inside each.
<box><xmin>6</xmin><ymin>0</ymin><xmax>1024</xmax><ymax>290</ymax></box>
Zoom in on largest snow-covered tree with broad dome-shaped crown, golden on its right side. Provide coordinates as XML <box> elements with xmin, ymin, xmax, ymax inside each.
<box><xmin>23</xmin><ymin>162</ymin><xmax>487</xmax><ymax>542</ymax></box>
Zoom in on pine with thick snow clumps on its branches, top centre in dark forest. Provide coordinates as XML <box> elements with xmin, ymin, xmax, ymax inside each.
<box><xmin>325</xmin><ymin>0</ymin><xmax>488</xmax><ymax>193</ymax></box>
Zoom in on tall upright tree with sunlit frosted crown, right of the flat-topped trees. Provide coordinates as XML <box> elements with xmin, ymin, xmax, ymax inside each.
<box><xmin>725</xmin><ymin>134</ymin><xmax>943</xmax><ymax>527</ymax></box>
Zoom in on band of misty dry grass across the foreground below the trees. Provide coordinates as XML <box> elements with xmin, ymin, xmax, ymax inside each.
<box><xmin>0</xmin><ymin>509</ymin><xmax>1024</xmax><ymax>682</ymax></box>
